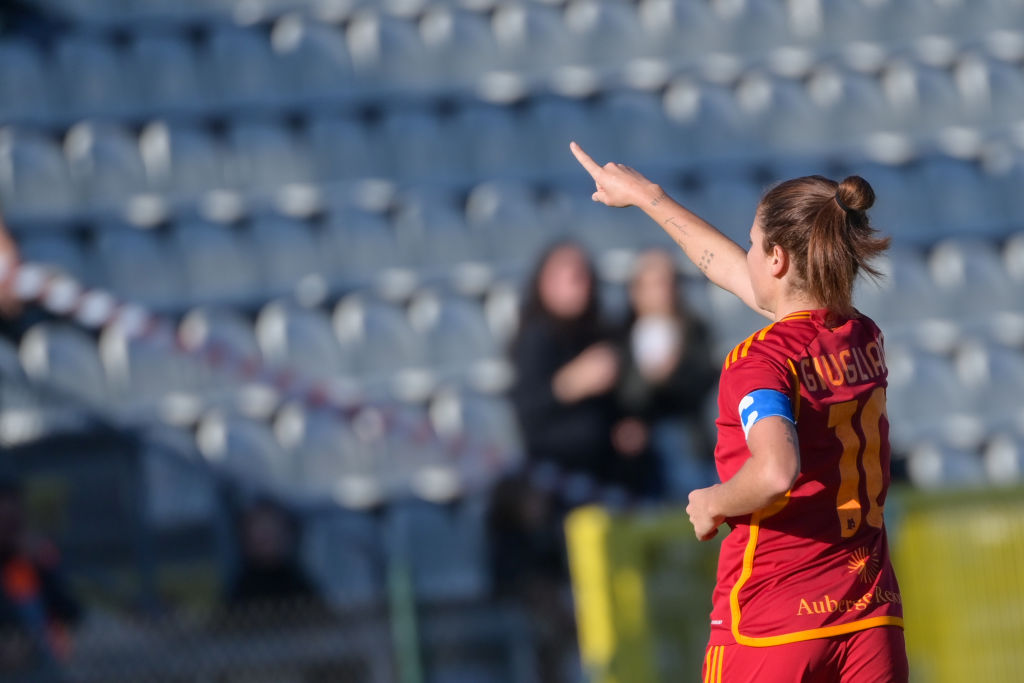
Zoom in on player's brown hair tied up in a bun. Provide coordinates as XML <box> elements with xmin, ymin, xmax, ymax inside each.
<box><xmin>758</xmin><ymin>175</ymin><xmax>889</xmax><ymax>314</ymax></box>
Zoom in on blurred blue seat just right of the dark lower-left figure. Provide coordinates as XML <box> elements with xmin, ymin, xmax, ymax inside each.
<box><xmin>302</xmin><ymin>510</ymin><xmax>387</xmax><ymax>609</ymax></box>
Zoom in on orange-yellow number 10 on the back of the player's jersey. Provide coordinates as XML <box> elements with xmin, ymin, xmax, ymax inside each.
<box><xmin>828</xmin><ymin>387</ymin><xmax>886</xmax><ymax>539</ymax></box>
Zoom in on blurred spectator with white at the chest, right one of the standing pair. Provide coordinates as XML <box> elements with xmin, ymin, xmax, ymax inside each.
<box><xmin>612</xmin><ymin>250</ymin><xmax>718</xmax><ymax>500</ymax></box>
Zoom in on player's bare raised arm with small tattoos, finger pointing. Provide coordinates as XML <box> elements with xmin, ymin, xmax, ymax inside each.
<box><xmin>569</xmin><ymin>142</ymin><xmax>772</xmax><ymax>317</ymax></box>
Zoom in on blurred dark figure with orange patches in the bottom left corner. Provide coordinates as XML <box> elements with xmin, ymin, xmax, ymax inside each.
<box><xmin>0</xmin><ymin>480</ymin><xmax>81</xmax><ymax>674</ymax></box>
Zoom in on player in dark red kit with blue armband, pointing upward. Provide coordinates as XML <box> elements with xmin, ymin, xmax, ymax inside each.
<box><xmin>571</xmin><ymin>142</ymin><xmax>908</xmax><ymax>683</ymax></box>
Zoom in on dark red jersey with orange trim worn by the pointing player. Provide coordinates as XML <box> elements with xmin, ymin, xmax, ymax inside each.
<box><xmin>711</xmin><ymin>310</ymin><xmax>903</xmax><ymax>646</ymax></box>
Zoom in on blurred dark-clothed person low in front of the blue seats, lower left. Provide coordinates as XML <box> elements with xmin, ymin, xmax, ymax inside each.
<box><xmin>227</xmin><ymin>500</ymin><xmax>317</xmax><ymax>607</ymax></box>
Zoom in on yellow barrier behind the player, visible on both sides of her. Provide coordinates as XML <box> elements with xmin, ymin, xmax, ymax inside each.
<box><xmin>566</xmin><ymin>489</ymin><xmax>1024</xmax><ymax>683</ymax></box>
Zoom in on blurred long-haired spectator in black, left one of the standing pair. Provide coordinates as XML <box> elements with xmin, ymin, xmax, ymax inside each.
<box><xmin>512</xmin><ymin>242</ymin><xmax>618</xmax><ymax>483</ymax></box>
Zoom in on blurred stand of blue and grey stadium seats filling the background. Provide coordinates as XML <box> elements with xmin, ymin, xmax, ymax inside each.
<box><xmin>0</xmin><ymin>0</ymin><xmax>1024</xmax><ymax>682</ymax></box>
